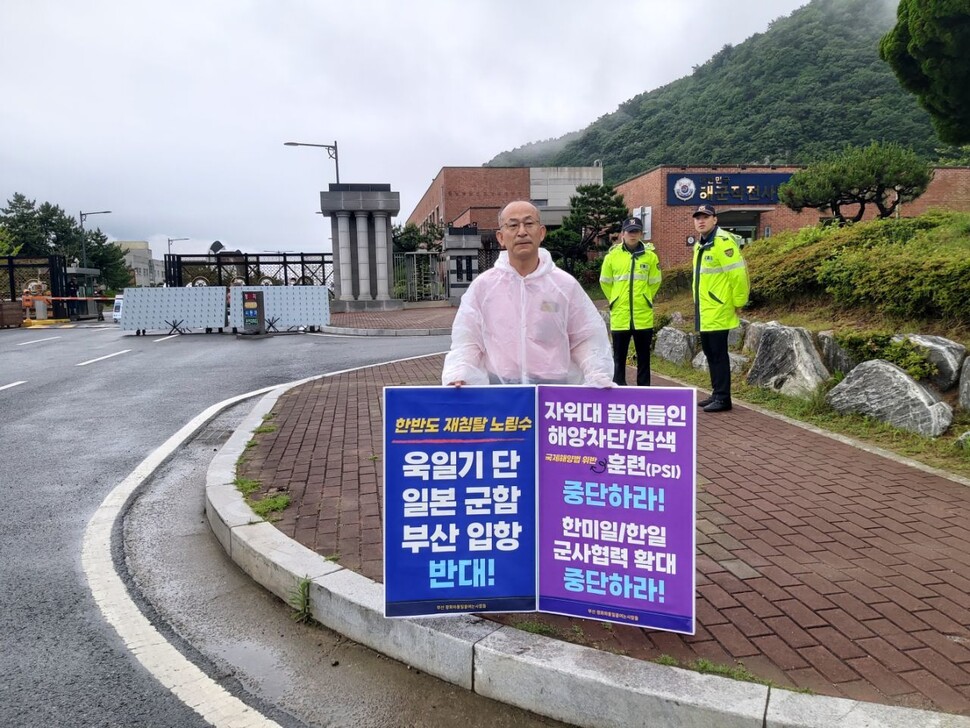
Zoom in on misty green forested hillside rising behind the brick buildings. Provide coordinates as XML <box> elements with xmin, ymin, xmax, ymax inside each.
<box><xmin>488</xmin><ymin>0</ymin><xmax>943</xmax><ymax>183</ymax></box>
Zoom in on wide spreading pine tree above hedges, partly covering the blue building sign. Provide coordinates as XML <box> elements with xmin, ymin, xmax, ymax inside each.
<box><xmin>778</xmin><ymin>142</ymin><xmax>933</xmax><ymax>223</ymax></box>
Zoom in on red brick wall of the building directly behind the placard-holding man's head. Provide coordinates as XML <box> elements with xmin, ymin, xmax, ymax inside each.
<box><xmin>407</xmin><ymin>167</ymin><xmax>529</xmax><ymax>227</ymax></box>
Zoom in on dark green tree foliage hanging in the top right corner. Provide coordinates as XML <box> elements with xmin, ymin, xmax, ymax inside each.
<box><xmin>879</xmin><ymin>0</ymin><xmax>970</xmax><ymax>144</ymax></box>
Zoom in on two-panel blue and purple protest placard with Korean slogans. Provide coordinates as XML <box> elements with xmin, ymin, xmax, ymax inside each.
<box><xmin>384</xmin><ymin>386</ymin><xmax>696</xmax><ymax>634</ymax></box>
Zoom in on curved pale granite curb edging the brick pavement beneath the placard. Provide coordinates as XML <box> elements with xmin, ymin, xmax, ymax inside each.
<box><xmin>205</xmin><ymin>380</ymin><xmax>970</xmax><ymax>728</ymax></box>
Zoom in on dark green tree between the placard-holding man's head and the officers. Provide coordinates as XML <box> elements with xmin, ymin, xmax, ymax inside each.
<box><xmin>546</xmin><ymin>184</ymin><xmax>630</xmax><ymax>270</ymax></box>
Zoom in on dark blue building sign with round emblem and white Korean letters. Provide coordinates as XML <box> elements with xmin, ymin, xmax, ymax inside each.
<box><xmin>667</xmin><ymin>172</ymin><xmax>792</xmax><ymax>207</ymax></box>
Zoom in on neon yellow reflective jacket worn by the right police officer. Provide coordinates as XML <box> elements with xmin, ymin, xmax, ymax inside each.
<box><xmin>692</xmin><ymin>228</ymin><xmax>750</xmax><ymax>331</ymax></box>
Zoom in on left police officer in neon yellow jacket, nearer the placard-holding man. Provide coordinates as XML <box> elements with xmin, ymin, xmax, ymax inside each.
<box><xmin>600</xmin><ymin>217</ymin><xmax>660</xmax><ymax>387</ymax></box>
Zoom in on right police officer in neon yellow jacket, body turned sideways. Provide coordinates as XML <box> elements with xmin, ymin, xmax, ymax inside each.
<box><xmin>693</xmin><ymin>205</ymin><xmax>749</xmax><ymax>412</ymax></box>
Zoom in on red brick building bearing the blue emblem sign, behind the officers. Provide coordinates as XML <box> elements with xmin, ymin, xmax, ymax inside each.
<box><xmin>616</xmin><ymin>165</ymin><xmax>970</xmax><ymax>268</ymax></box>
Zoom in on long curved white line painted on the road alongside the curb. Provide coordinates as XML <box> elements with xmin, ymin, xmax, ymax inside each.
<box><xmin>81</xmin><ymin>352</ymin><xmax>441</xmax><ymax>728</ymax></box>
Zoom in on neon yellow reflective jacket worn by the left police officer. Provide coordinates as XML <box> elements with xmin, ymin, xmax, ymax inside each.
<box><xmin>600</xmin><ymin>242</ymin><xmax>660</xmax><ymax>331</ymax></box>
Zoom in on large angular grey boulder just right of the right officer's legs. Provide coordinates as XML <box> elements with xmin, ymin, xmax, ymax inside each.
<box><xmin>748</xmin><ymin>323</ymin><xmax>829</xmax><ymax>397</ymax></box>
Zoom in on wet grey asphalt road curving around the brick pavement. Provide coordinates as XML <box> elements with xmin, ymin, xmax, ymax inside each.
<box><xmin>0</xmin><ymin>323</ymin><xmax>564</xmax><ymax>727</ymax></box>
